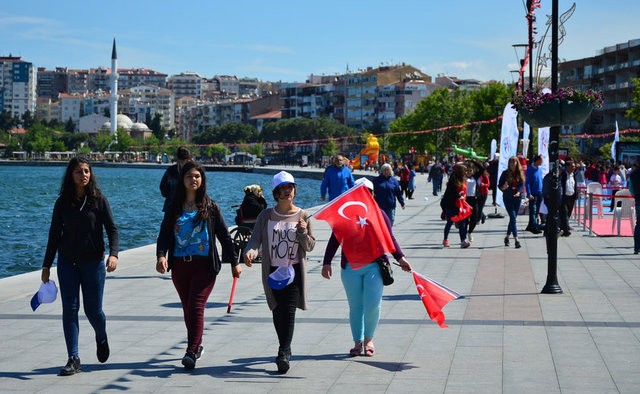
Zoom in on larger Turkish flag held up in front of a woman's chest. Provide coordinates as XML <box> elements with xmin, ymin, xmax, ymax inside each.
<box><xmin>314</xmin><ymin>185</ymin><xmax>396</xmax><ymax>266</ymax></box>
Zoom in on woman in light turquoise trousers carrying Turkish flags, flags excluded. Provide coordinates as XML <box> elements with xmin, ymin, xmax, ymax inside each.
<box><xmin>322</xmin><ymin>178</ymin><xmax>411</xmax><ymax>357</ymax></box>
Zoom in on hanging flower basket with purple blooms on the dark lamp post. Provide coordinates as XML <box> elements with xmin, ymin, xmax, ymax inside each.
<box><xmin>511</xmin><ymin>88</ymin><xmax>604</xmax><ymax>128</ymax></box>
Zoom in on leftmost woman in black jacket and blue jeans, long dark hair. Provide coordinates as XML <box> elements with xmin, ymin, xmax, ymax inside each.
<box><xmin>41</xmin><ymin>157</ymin><xmax>119</xmax><ymax>376</ymax></box>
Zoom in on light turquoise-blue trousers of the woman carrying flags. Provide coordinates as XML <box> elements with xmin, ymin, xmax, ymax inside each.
<box><xmin>340</xmin><ymin>263</ymin><xmax>383</xmax><ymax>342</ymax></box>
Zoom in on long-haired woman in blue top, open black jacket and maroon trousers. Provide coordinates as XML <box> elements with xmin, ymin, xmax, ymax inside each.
<box><xmin>156</xmin><ymin>161</ymin><xmax>242</xmax><ymax>369</ymax></box>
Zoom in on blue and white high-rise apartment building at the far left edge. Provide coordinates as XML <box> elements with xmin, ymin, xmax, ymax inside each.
<box><xmin>0</xmin><ymin>55</ymin><xmax>37</xmax><ymax>117</ymax></box>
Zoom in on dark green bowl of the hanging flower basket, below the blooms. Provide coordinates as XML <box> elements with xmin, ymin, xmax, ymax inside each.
<box><xmin>520</xmin><ymin>99</ymin><xmax>593</xmax><ymax>128</ymax></box>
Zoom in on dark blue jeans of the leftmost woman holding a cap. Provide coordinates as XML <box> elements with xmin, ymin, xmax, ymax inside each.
<box><xmin>58</xmin><ymin>256</ymin><xmax>107</xmax><ymax>357</ymax></box>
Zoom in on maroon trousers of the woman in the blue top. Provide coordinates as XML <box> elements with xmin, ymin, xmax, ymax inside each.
<box><xmin>171</xmin><ymin>256</ymin><xmax>216</xmax><ymax>353</ymax></box>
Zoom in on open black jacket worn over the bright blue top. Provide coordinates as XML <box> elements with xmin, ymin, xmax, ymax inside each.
<box><xmin>156</xmin><ymin>203</ymin><xmax>239</xmax><ymax>275</ymax></box>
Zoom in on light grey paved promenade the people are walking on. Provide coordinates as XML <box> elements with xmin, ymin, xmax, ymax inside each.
<box><xmin>0</xmin><ymin>173</ymin><xmax>640</xmax><ymax>394</ymax></box>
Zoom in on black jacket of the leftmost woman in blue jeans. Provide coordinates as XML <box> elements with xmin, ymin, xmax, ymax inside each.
<box><xmin>42</xmin><ymin>195</ymin><xmax>120</xmax><ymax>267</ymax></box>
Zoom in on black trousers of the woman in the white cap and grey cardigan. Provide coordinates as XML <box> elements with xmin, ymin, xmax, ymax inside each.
<box><xmin>271</xmin><ymin>264</ymin><xmax>302</xmax><ymax>352</ymax></box>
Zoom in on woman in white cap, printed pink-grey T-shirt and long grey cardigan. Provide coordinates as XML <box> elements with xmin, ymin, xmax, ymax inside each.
<box><xmin>244</xmin><ymin>171</ymin><xmax>316</xmax><ymax>373</ymax></box>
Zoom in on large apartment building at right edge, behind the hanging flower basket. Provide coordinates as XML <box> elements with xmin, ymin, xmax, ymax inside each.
<box><xmin>558</xmin><ymin>39</ymin><xmax>640</xmax><ymax>133</ymax></box>
